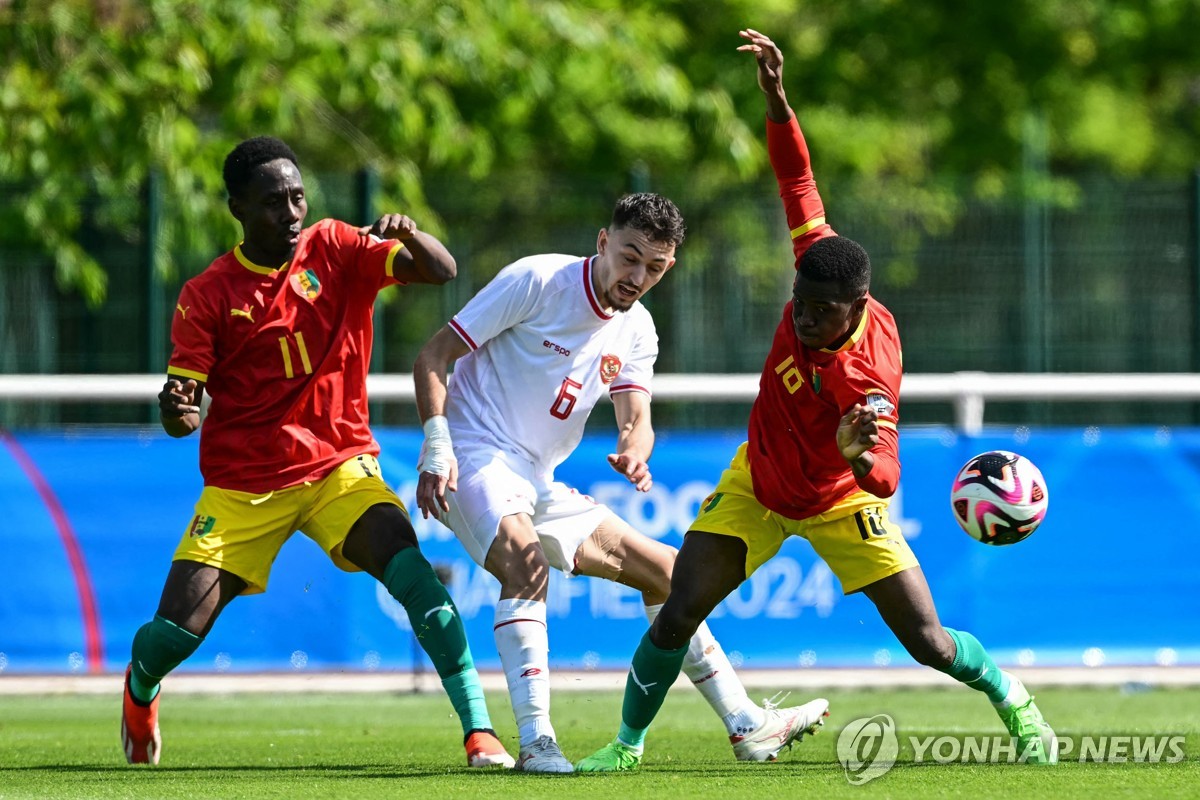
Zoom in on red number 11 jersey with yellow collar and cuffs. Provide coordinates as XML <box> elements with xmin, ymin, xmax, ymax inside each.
<box><xmin>167</xmin><ymin>219</ymin><xmax>403</xmax><ymax>494</ymax></box>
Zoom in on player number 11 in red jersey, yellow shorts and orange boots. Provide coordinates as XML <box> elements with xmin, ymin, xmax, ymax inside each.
<box><xmin>121</xmin><ymin>137</ymin><xmax>514</xmax><ymax>766</ymax></box>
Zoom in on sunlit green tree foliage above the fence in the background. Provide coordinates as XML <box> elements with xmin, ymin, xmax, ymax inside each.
<box><xmin>0</xmin><ymin>0</ymin><xmax>1200</xmax><ymax>302</ymax></box>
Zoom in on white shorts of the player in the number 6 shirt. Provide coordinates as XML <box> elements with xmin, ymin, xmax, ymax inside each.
<box><xmin>442</xmin><ymin>441</ymin><xmax>611</xmax><ymax>575</ymax></box>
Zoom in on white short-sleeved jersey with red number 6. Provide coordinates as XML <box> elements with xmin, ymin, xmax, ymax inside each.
<box><xmin>446</xmin><ymin>253</ymin><xmax>659</xmax><ymax>475</ymax></box>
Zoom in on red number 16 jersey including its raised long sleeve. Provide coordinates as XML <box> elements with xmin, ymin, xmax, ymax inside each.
<box><xmin>748</xmin><ymin>116</ymin><xmax>901</xmax><ymax>519</ymax></box>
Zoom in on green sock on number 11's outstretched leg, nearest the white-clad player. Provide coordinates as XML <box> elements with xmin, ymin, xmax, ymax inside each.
<box><xmin>383</xmin><ymin>547</ymin><xmax>492</xmax><ymax>733</ymax></box>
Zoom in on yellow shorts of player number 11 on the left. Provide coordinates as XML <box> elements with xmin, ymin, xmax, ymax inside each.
<box><xmin>173</xmin><ymin>455</ymin><xmax>408</xmax><ymax>595</ymax></box>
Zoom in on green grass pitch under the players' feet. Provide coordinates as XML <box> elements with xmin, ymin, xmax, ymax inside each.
<box><xmin>0</xmin><ymin>681</ymin><xmax>1200</xmax><ymax>800</ymax></box>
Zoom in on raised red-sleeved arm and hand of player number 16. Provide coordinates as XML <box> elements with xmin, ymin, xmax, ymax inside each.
<box><xmin>738</xmin><ymin>29</ymin><xmax>836</xmax><ymax>264</ymax></box>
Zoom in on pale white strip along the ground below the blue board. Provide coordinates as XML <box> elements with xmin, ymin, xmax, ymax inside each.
<box><xmin>0</xmin><ymin>667</ymin><xmax>1200</xmax><ymax>697</ymax></box>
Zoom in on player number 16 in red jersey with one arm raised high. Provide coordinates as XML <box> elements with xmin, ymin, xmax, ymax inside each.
<box><xmin>576</xmin><ymin>30</ymin><xmax>1056</xmax><ymax>771</ymax></box>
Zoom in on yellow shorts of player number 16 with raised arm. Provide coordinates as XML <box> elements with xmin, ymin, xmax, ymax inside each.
<box><xmin>691</xmin><ymin>444</ymin><xmax>917</xmax><ymax>595</ymax></box>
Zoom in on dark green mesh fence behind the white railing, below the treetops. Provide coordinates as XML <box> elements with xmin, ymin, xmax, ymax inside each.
<box><xmin>0</xmin><ymin>174</ymin><xmax>1200</xmax><ymax>427</ymax></box>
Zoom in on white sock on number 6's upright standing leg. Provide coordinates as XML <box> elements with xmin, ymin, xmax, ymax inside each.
<box><xmin>493</xmin><ymin>600</ymin><xmax>554</xmax><ymax>747</ymax></box>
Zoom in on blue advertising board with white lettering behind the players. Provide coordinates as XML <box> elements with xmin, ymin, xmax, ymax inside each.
<box><xmin>0</xmin><ymin>428</ymin><xmax>1200</xmax><ymax>673</ymax></box>
